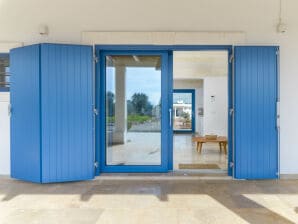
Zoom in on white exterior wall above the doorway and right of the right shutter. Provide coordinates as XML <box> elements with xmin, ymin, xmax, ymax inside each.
<box><xmin>0</xmin><ymin>0</ymin><xmax>298</xmax><ymax>174</ymax></box>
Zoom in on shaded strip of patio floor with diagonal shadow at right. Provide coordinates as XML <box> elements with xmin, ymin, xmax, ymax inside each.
<box><xmin>0</xmin><ymin>177</ymin><xmax>298</xmax><ymax>223</ymax></box>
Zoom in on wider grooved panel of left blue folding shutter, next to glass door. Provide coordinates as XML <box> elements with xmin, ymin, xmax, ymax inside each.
<box><xmin>41</xmin><ymin>44</ymin><xmax>94</xmax><ymax>182</ymax></box>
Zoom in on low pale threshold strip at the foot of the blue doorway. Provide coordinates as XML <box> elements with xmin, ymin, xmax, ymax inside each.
<box><xmin>96</xmin><ymin>170</ymin><xmax>233</xmax><ymax>181</ymax></box>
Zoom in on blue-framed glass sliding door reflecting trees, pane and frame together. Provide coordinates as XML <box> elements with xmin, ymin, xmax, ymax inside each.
<box><xmin>100</xmin><ymin>51</ymin><xmax>171</xmax><ymax>172</ymax></box>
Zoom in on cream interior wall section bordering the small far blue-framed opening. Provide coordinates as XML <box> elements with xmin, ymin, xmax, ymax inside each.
<box><xmin>173</xmin><ymin>79</ymin><xmax>204</xmax><ymax>134</ymax></box>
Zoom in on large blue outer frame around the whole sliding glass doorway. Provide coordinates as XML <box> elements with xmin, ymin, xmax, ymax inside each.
<box><xmin>95</xmin><ymin>45</ymin><xmax>234</xmax><ymax>176</ymax></box>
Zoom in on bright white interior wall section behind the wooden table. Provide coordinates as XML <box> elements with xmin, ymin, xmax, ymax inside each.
<box><xmin>204</xmin><ymin>76</ymin><xmax>228</xmax><ymax>136</ymax></box>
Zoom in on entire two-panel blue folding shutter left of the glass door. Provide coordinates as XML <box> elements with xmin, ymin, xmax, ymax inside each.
<box><xmin>11</xmin><ymin>44</ymin><xmax>94</xmax><ymax>183</ymax></box>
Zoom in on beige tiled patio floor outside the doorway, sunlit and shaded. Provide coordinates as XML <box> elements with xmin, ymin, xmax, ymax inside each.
<box><xmin>0</xmin><ymin>176</ymin><xmax>298</xmax><ymax>224</ymax></box>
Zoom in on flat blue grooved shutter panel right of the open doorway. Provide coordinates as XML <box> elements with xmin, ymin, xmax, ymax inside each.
<box><xmin>235</xmin><ymin>46</ymin><xmax>278</xmax><ymax>179</ymax></box>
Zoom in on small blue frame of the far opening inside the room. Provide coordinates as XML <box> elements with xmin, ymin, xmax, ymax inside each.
<box><xmin>173</xmin><ymin>89</ymin><xmax>196</xmax><ymax>133</ymax></box>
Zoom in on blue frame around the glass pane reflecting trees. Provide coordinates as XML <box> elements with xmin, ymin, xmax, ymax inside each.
<box><xmin>96</xmin><ymin>50</ymin><xmax>171</xmax><ymax>173</ymax></box>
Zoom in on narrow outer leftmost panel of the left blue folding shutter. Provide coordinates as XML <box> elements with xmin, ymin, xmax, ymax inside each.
<box><xmin>10</xmin><ymin>45</ymin><xmax>41</xmax><ymax>182</ymax></box>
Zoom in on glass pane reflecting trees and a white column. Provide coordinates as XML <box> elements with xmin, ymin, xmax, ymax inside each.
<box><xmin>105</xmin><ymin>54</ymin><xmax>162</xmax><ymax>165</ymax></box>
